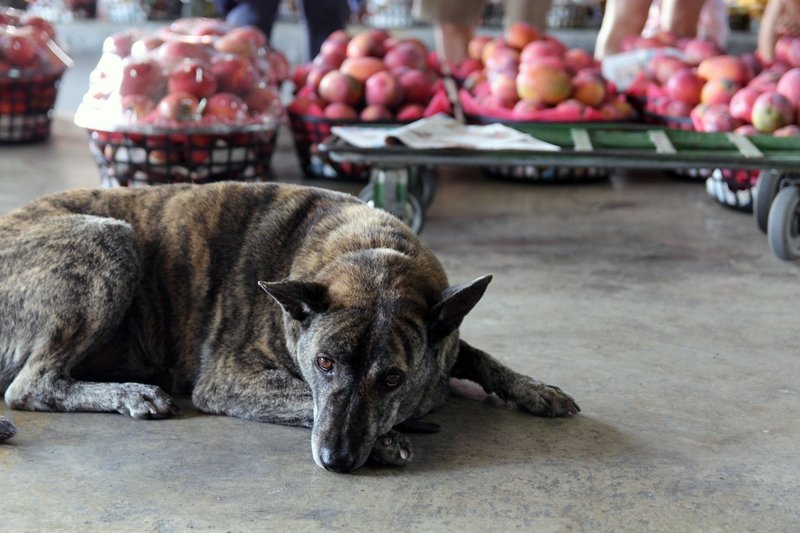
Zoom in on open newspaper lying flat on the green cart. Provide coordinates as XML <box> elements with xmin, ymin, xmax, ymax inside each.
<box><xmin>331</xmin><ymin>114</ymin><xmax>560</xmax><ymax>151</ymax></box>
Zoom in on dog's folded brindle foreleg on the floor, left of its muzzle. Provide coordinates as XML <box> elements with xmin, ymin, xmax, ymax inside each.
<box><xmin>192</xmin><ymin>356</ymin><xmax>314</xmax><ymax>427</ymax></box>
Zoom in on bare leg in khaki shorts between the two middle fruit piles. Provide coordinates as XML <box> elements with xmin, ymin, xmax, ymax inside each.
<box><xmin>414</xmin><ymin>0</ymin><xmax>486</xmax><ymax>64</ymax></box>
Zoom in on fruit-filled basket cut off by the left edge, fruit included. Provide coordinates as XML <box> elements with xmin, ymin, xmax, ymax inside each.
<box><xmin>0</xmin><ymin>8</ymin><xmax>71</xmax><ymax>143</ymax></box>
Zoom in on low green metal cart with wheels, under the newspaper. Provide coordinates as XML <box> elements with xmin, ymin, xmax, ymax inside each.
<box><xmin>319</xmin><ymin>123</ymin><xmax>800</xmax><ymax>261</ymax></box>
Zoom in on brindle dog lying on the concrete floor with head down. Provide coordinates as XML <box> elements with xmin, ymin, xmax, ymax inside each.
<box><xmin>0</xmin><ymin>183</ymin><xmax>579</xmax><ymax>472</ymax></box>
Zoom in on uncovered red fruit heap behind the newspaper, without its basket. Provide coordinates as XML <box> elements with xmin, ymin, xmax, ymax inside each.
<box><xmin>289</xmin><ymin>29</ymin><xmax>451</xmax><ymax>122</ymax></box>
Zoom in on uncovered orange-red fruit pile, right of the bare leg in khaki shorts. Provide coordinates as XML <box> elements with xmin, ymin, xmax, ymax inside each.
<box><xmin>460</xmin><ymin>22</ymin><xmax>634</xmax><ymax>121</ymax></box>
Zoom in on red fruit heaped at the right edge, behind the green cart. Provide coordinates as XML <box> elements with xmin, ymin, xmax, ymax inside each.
<box><xmin>628</xmin><ymin>32</ymin><xmax>800</xmax><ymax>136</ymax></box>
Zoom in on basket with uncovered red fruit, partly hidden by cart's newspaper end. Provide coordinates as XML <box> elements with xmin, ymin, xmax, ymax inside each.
<box><xmin>288</xmin><ymin>29</ymin><xmax>452</xmax><ymax>181</ymax></box>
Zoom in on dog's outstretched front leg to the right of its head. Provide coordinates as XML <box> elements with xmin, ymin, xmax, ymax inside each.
<box><xmin>451</xmin><ymin>341</ymin><xmax>581</xmax><ymax>416</ymax></box>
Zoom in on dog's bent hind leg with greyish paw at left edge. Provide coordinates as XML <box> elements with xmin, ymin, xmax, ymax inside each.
<box><xmin>0</xmin><ymin>215</ymin><xmax>174</xmax><ymax>418</ymax></box>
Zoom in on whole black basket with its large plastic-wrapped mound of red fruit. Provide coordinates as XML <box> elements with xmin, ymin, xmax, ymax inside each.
<box><xmin>75</xmin><ymin>18</ymin><xmax>283</xmax><ymax>187</ymax></box>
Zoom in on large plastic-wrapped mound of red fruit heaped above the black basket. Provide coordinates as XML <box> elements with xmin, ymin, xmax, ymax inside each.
<box><xmin>76</xmin><ymin>18</ymin><xmax>289</xmax><ymax>132</ymax></box>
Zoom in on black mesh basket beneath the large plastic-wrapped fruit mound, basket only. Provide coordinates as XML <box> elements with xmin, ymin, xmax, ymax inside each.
<box><xmin>88</xmin><ymin>126</ymin><xmax>278</xmax><ymax>187</ymax></box>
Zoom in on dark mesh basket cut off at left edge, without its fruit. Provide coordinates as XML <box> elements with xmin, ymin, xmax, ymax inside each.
<box><xmin>0</xmin><ymin>72</ymin><xmax>63</xmax><ymax>143</ymax></box>
